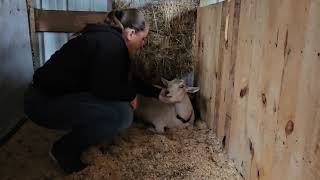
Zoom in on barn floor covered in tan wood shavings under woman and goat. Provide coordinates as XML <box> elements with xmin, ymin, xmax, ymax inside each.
<box><xmin>0</xmin><ymin>122</ymin><xmax>242</xmax><ymax>180</ymax></box>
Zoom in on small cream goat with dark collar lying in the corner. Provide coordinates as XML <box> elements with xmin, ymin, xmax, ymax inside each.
<box><xmin>136</xmin><ymin>78</ymin><xmax>199</xmax><ymax>133</ymax></box>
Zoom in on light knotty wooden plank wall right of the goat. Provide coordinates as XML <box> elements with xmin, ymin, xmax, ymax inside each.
<box><xmin>196</xmin><ymin>0</ymin><xmax>320</xmax><ymax>180</ymax></box>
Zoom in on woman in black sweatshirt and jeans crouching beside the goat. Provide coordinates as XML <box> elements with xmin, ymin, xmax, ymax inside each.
<box><xmin>25</xmin><ymin>9</ymin><xmax>171</xmax><ymax>173</ymax></box>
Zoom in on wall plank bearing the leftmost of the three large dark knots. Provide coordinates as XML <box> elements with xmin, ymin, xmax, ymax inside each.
<box><xmin>228</xmin><ymin>0</ymin><xmax>257</xmax><ymax>179</ymax></box>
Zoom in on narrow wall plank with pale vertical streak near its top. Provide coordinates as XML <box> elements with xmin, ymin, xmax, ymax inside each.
<box><xmin>216</xmin><ymin>0</ymin><xmax>241</xmax><ymax>149</ymax></box>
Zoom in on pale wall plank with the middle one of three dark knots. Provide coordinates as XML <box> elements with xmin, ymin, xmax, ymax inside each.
<box><xmin>238</xmin><ymin>1</ymin><xmax>268</xmax><ymax>180</ymax></box>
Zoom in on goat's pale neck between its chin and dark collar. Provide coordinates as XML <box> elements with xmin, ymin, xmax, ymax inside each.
<box><xmin>175</xmin><ymin>95</ymin><xmax>193</xmax><ymax>119</ymax></box>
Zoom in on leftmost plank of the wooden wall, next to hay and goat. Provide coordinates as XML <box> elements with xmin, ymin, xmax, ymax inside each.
<box><xmin>196</xmin><ymin>4</ymin><xmax>223</xmax><ymax>129</ymax></box>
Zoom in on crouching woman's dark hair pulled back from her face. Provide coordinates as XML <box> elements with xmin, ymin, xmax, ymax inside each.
<box><xmin>104</xmin><ymin>8</ymin><xmax>146</xmax><ymax>32</ymax></box>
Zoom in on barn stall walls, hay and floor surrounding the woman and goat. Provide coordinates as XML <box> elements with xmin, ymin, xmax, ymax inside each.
<box><xmin>0</xmin><ymin>0</ymin><xmax>320</xmax><ymax>180</ymax></box>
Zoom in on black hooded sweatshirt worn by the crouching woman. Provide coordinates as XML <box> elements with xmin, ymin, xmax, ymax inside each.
<box><xmin>33</xmin><ymin>24</ymin><xmax>160</xmax><ymax>101</ymax></box>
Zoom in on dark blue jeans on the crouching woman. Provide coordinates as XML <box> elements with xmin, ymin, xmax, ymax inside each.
<box><xmin>24</xmin><ymin>87</ymin><xmax>133</xmax><ymax>162</ymax></box>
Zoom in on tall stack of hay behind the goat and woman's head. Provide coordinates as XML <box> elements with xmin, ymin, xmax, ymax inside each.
<box><xmin>115</xmin><ymin>0</ymin><xmax>199</xmax><ymax>82</ymax></box>
